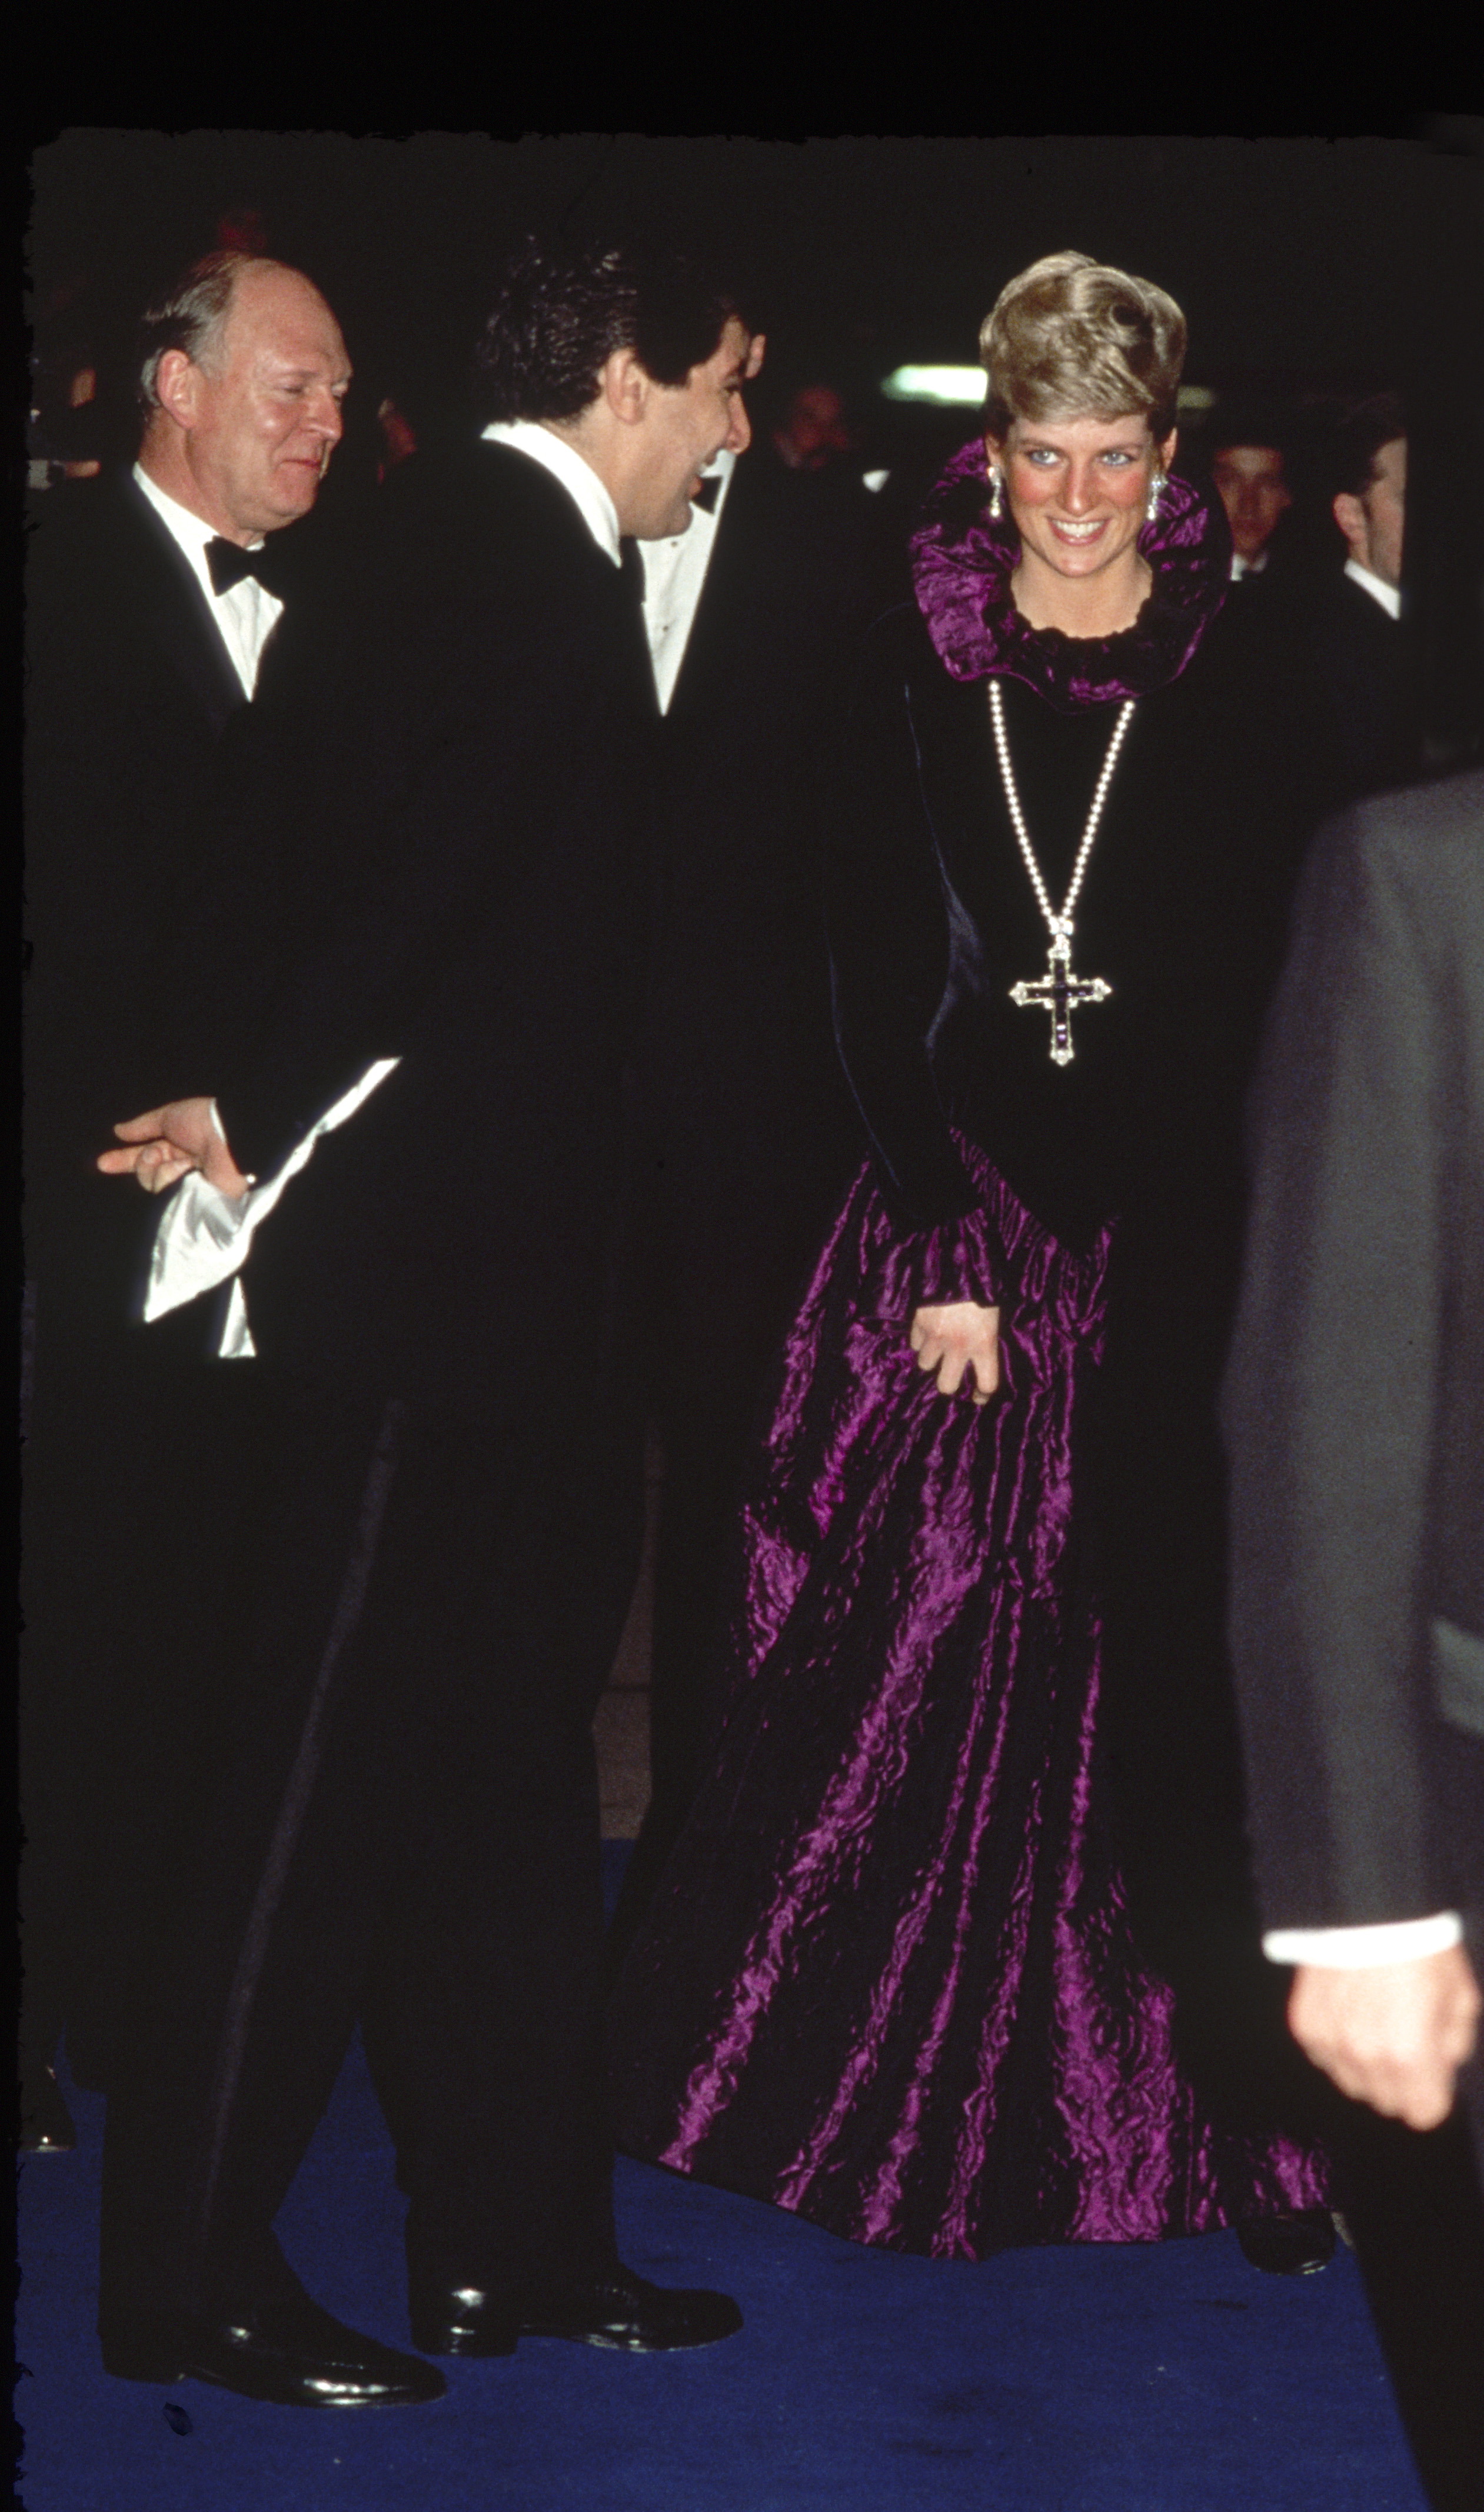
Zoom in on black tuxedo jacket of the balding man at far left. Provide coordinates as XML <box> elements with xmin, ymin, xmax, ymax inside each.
<box><xmin>25</xmin><ymin>475</ymin><xmax>248</xmax><ymax>1326</ymax></box>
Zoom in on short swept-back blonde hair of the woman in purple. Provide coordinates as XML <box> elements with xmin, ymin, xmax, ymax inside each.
<box><xmin>979</xmin><ymin>254</ymin><xmax>1185</xmax><ymax>442</ymax></box>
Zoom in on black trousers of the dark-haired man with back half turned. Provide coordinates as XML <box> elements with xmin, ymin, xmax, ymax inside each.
<box><xmin>101</xmin><ymin>1362</ymin><xmax>643</xmax><ymax>2314</ymax></box>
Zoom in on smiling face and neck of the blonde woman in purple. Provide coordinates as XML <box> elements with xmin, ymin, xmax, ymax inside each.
<box><xmin>987</xmin><ymin>417</ymin><xmax>1175</xmax><ymax>636</ymax></box>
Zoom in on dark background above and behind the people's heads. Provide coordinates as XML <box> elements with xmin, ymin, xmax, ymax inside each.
<box><xmin>28</xmin><ymin>134</ymin><xmax>1484</xmax><ymax>756</ymax></box>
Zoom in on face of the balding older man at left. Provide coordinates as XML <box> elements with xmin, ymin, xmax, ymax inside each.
<box><xmin>184</xmin><ymin>271</ymin><xmax>351</xmax><ymax>543</ymax></box>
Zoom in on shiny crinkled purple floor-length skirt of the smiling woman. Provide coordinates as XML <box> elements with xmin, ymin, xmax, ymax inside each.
<box><xmin>613</xmin><ymin>1146</ymin><xmax>1326</xmax><ymax>2258</ymax></box>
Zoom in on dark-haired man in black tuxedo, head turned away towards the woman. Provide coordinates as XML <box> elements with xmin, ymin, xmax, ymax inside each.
<box><xmin>87</xmin><ymin>246</ymin><xmax>751</xmax><ymax>2404</ymax></box>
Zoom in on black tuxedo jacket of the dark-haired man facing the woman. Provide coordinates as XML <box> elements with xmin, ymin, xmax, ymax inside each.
<box><xmin>194</xmin><ymin>442</ymin><xmax>658</xmax><ymax>1419</ymax></box>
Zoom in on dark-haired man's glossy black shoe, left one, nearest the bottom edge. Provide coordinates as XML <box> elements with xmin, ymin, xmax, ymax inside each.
<box><xmin>98</xmin><ymin>2291</ymin><xmax>447</xmax><ymax>2407</ymax></box>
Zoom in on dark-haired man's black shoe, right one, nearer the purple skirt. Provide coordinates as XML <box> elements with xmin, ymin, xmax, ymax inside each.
<box><xmin>412</xmin><ymin>2266</ymin><xmax>741</xmax><ymax>2356</ymax></box>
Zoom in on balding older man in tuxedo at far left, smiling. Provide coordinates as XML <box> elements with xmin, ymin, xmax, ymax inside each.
<box><xmin>22</xmin><ymin>251</ymin><xmax>351</xmax><ymax>2153</ymax></box>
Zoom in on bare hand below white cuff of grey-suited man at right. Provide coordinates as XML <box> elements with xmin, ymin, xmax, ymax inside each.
<box><xmin>1288</xmin><ymin>1944</ymin><xmax>1484</xmax><ymax>2128</ymax></box>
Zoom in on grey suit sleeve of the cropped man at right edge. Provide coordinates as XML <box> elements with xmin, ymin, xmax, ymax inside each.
<box><xmin>1225</xmin><ymin>774</ymin><xmax>1484</xmax><ymax>1927</ymax></box>
